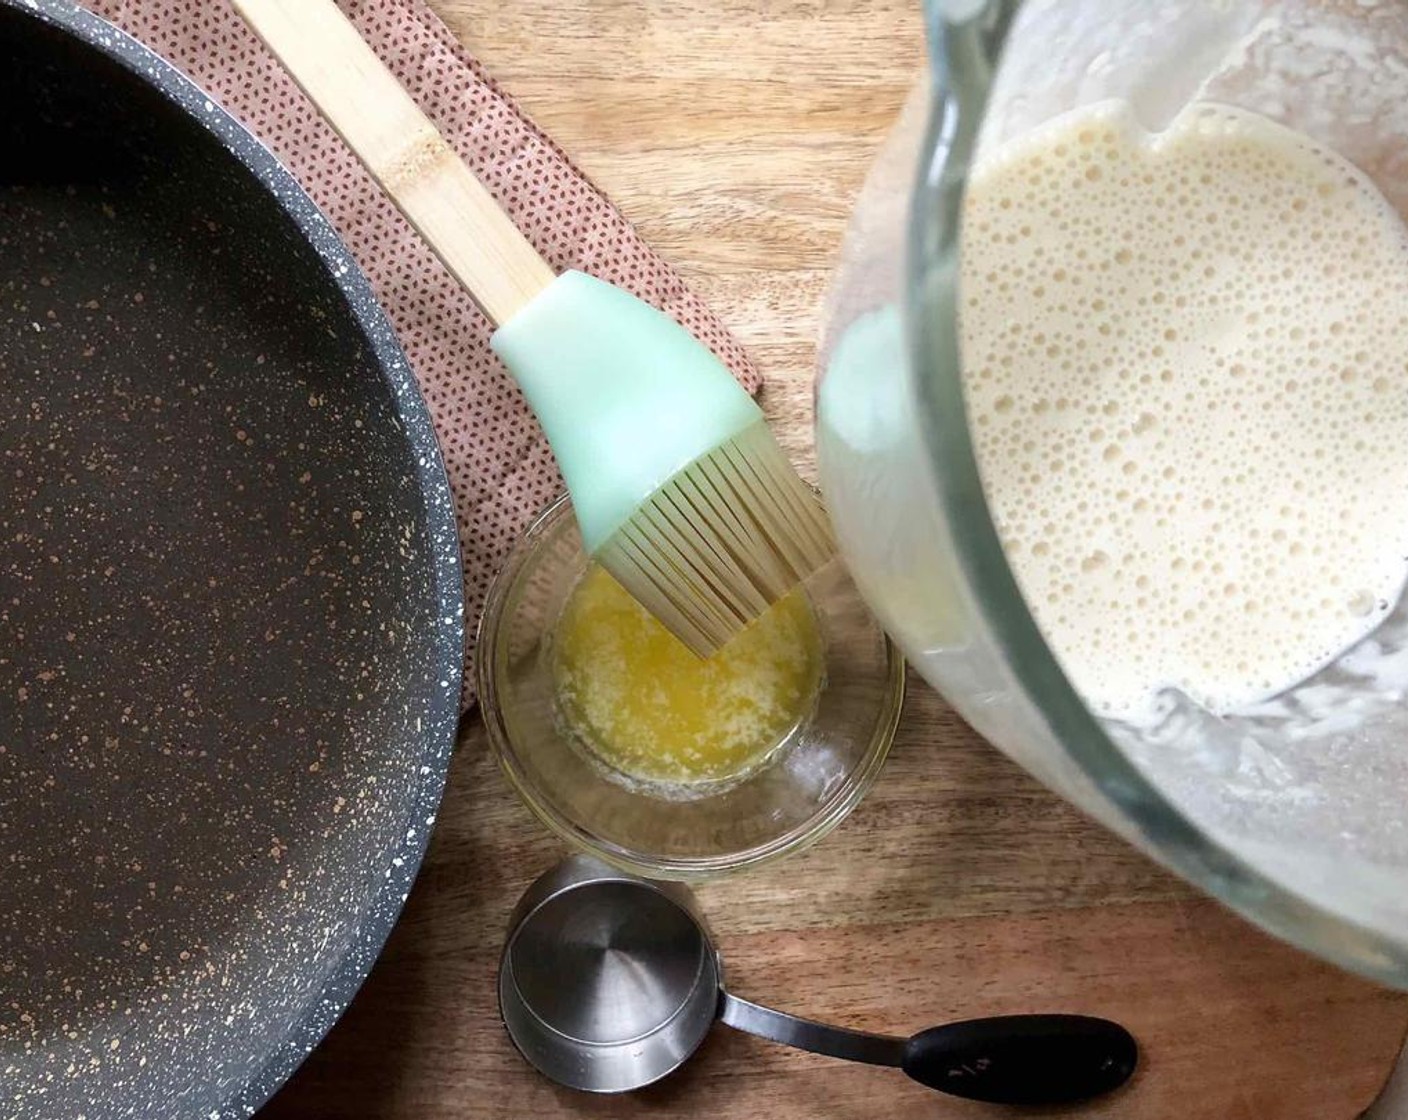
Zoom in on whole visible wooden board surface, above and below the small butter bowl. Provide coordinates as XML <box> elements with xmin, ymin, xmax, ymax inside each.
<box><xmin>265</xmin><ymin>0</ymin><xmax>1408</xmax><ymax>1120</ymax></box>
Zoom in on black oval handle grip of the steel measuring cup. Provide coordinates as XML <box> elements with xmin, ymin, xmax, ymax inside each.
<box><xmin>900</xmin><ymin>1014</ymin><xmax>1139</xmax><ymax>1105</ymax></box>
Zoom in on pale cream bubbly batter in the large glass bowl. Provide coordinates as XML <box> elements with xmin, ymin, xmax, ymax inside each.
<box><xmin>962</xmin><ymin>103</ymin><xmax>1408</xmax><ymax>717</ymax></box>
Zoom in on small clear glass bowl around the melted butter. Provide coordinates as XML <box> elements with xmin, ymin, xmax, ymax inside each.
<box><xmin>477</xmin><ymin>497</ymin><xmax>904</xmax><ymax>879</ymax></box>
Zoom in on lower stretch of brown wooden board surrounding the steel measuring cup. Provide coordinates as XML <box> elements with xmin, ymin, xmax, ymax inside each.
<box><xmin>268</xmin><ymin>710</ymin><xmax>1408</xmax><ymax>1120</ymax></box>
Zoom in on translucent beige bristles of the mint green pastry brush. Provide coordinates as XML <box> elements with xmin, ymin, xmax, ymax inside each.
<box><xmin>596</xmin><ymin>423</ymin><xmax>836</xmax><ymax>657</ymax></box>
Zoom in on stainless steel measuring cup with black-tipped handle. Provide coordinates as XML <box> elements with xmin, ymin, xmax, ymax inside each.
<box><xmin>498</xmin><ymin>855</ymin><xmax>1138</xmax><ymax>1105</ymax></box>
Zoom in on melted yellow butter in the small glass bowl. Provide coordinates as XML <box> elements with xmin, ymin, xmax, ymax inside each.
<box><xmin>553</xmin><ymin>565</ymin><xmax>822</xmax><ymax>785</ymax></box>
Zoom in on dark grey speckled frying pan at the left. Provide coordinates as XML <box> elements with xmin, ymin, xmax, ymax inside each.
<box><xmin>0</xmin><ymin>0</ymin><xmax>463</xmax><ymax>1120</ymax></box>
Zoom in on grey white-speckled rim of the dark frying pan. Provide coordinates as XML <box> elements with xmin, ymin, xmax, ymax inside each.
<box><xmin>0</xmin><ymin>0</ymin><xmax>465</xmax><ymax>1120</ymax></box>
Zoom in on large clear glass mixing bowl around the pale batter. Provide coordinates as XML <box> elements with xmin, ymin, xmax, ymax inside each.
<box><xmin>817</xmin><ymin>0</ymin><xmax>1408</xmax><ymax>988</ymax></box>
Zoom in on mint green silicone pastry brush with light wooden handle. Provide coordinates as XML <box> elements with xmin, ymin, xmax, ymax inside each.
<box><xmin>234</xmin><ymin>0</ymin><xmax>835</xmax><ymax>657</ymax></box>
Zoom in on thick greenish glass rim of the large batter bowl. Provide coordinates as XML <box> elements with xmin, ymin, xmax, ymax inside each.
<box><xmin>903</xmin><ymin>0</ymin><xmax>1408</xmax><ymax>989</ymax></box>
